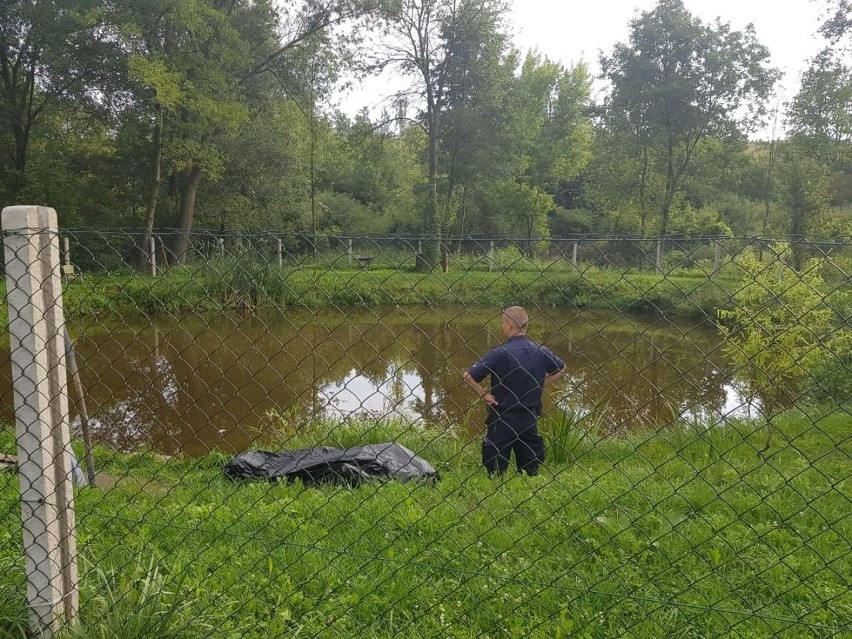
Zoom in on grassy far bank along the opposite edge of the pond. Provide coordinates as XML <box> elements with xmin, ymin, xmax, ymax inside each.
<box><xmin>53</xmin><ymin>263</ymin><xmax>737</xmax><ymax>319</ymax></box>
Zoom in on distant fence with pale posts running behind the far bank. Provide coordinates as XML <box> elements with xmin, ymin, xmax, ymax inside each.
<box><xmin>43</xmin><ymin>229</ymin><xmax>852</xmax><ymax>272</ymax></box>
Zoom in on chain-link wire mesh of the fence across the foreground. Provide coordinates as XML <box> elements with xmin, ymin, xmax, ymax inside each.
<box><xmin>0</xmin><ymin>230</ymin><xmax>852</xmax><ymax>638</ymax></box>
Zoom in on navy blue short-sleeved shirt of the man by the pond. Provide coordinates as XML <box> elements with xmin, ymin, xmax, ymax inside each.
<box><xmin>468</xmin><ymin>335</ymin><xmax>565</xmax><ymax>415</ymax></box>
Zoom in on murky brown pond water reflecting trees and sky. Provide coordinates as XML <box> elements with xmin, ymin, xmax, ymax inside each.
<box><xmin>0</xmin><ymin>307</ymin><xmax>755</xmax><ymax>456</ymax></box>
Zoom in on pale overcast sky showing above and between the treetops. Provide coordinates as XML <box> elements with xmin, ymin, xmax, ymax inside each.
<box><xmin>339</xmin><ymin>0</ymin><xmax>836</xmax><ymax>137</ymax></box>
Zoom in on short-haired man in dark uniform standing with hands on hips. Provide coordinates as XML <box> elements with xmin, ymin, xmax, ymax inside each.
<box><xmin>464</xmin><ymin>306</ymin><xmax>565</xmax><ymax>475</ymax></box>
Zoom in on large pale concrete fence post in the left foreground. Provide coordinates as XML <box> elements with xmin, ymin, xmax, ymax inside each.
<box><xmin>2</xmin><ymin>206</ymin><xmax>78</xmax><ymax>637</ymax></box>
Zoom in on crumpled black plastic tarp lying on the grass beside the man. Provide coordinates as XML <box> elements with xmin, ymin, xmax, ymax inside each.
<box><xmin>224</xmin><ymin>442</ymin><xmax>438</xmax><ymax>485</ymax></box>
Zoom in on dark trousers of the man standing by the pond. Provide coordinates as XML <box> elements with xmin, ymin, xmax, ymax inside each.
<box><xmin>482</xmin><ymin>411</ymin><xmax>544</xmax><ymax>475</ymax></box>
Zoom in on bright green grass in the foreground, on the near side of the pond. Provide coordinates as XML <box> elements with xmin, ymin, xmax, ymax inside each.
<box><xmin>0</xmin><ymin>409</ymin><xmax>852</xmax><ymax>639</ymax></box>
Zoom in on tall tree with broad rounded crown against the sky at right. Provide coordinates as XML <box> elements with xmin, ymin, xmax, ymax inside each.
<box><xmin>601</xmin><ymin>0</ymin><xmax>778</xmax><ymax>234</ymax></box>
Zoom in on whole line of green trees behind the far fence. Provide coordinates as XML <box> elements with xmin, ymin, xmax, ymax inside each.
<box><xmin>0</xmin><ymin>0</ymin><xmax>852</xmax><ymax>264</ymax></box>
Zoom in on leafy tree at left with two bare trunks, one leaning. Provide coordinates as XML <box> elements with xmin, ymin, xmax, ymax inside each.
<box><xmin>111</xmin><ymin>0</ymin><xmax>262</xmax><ymax>263</ymax></box>
